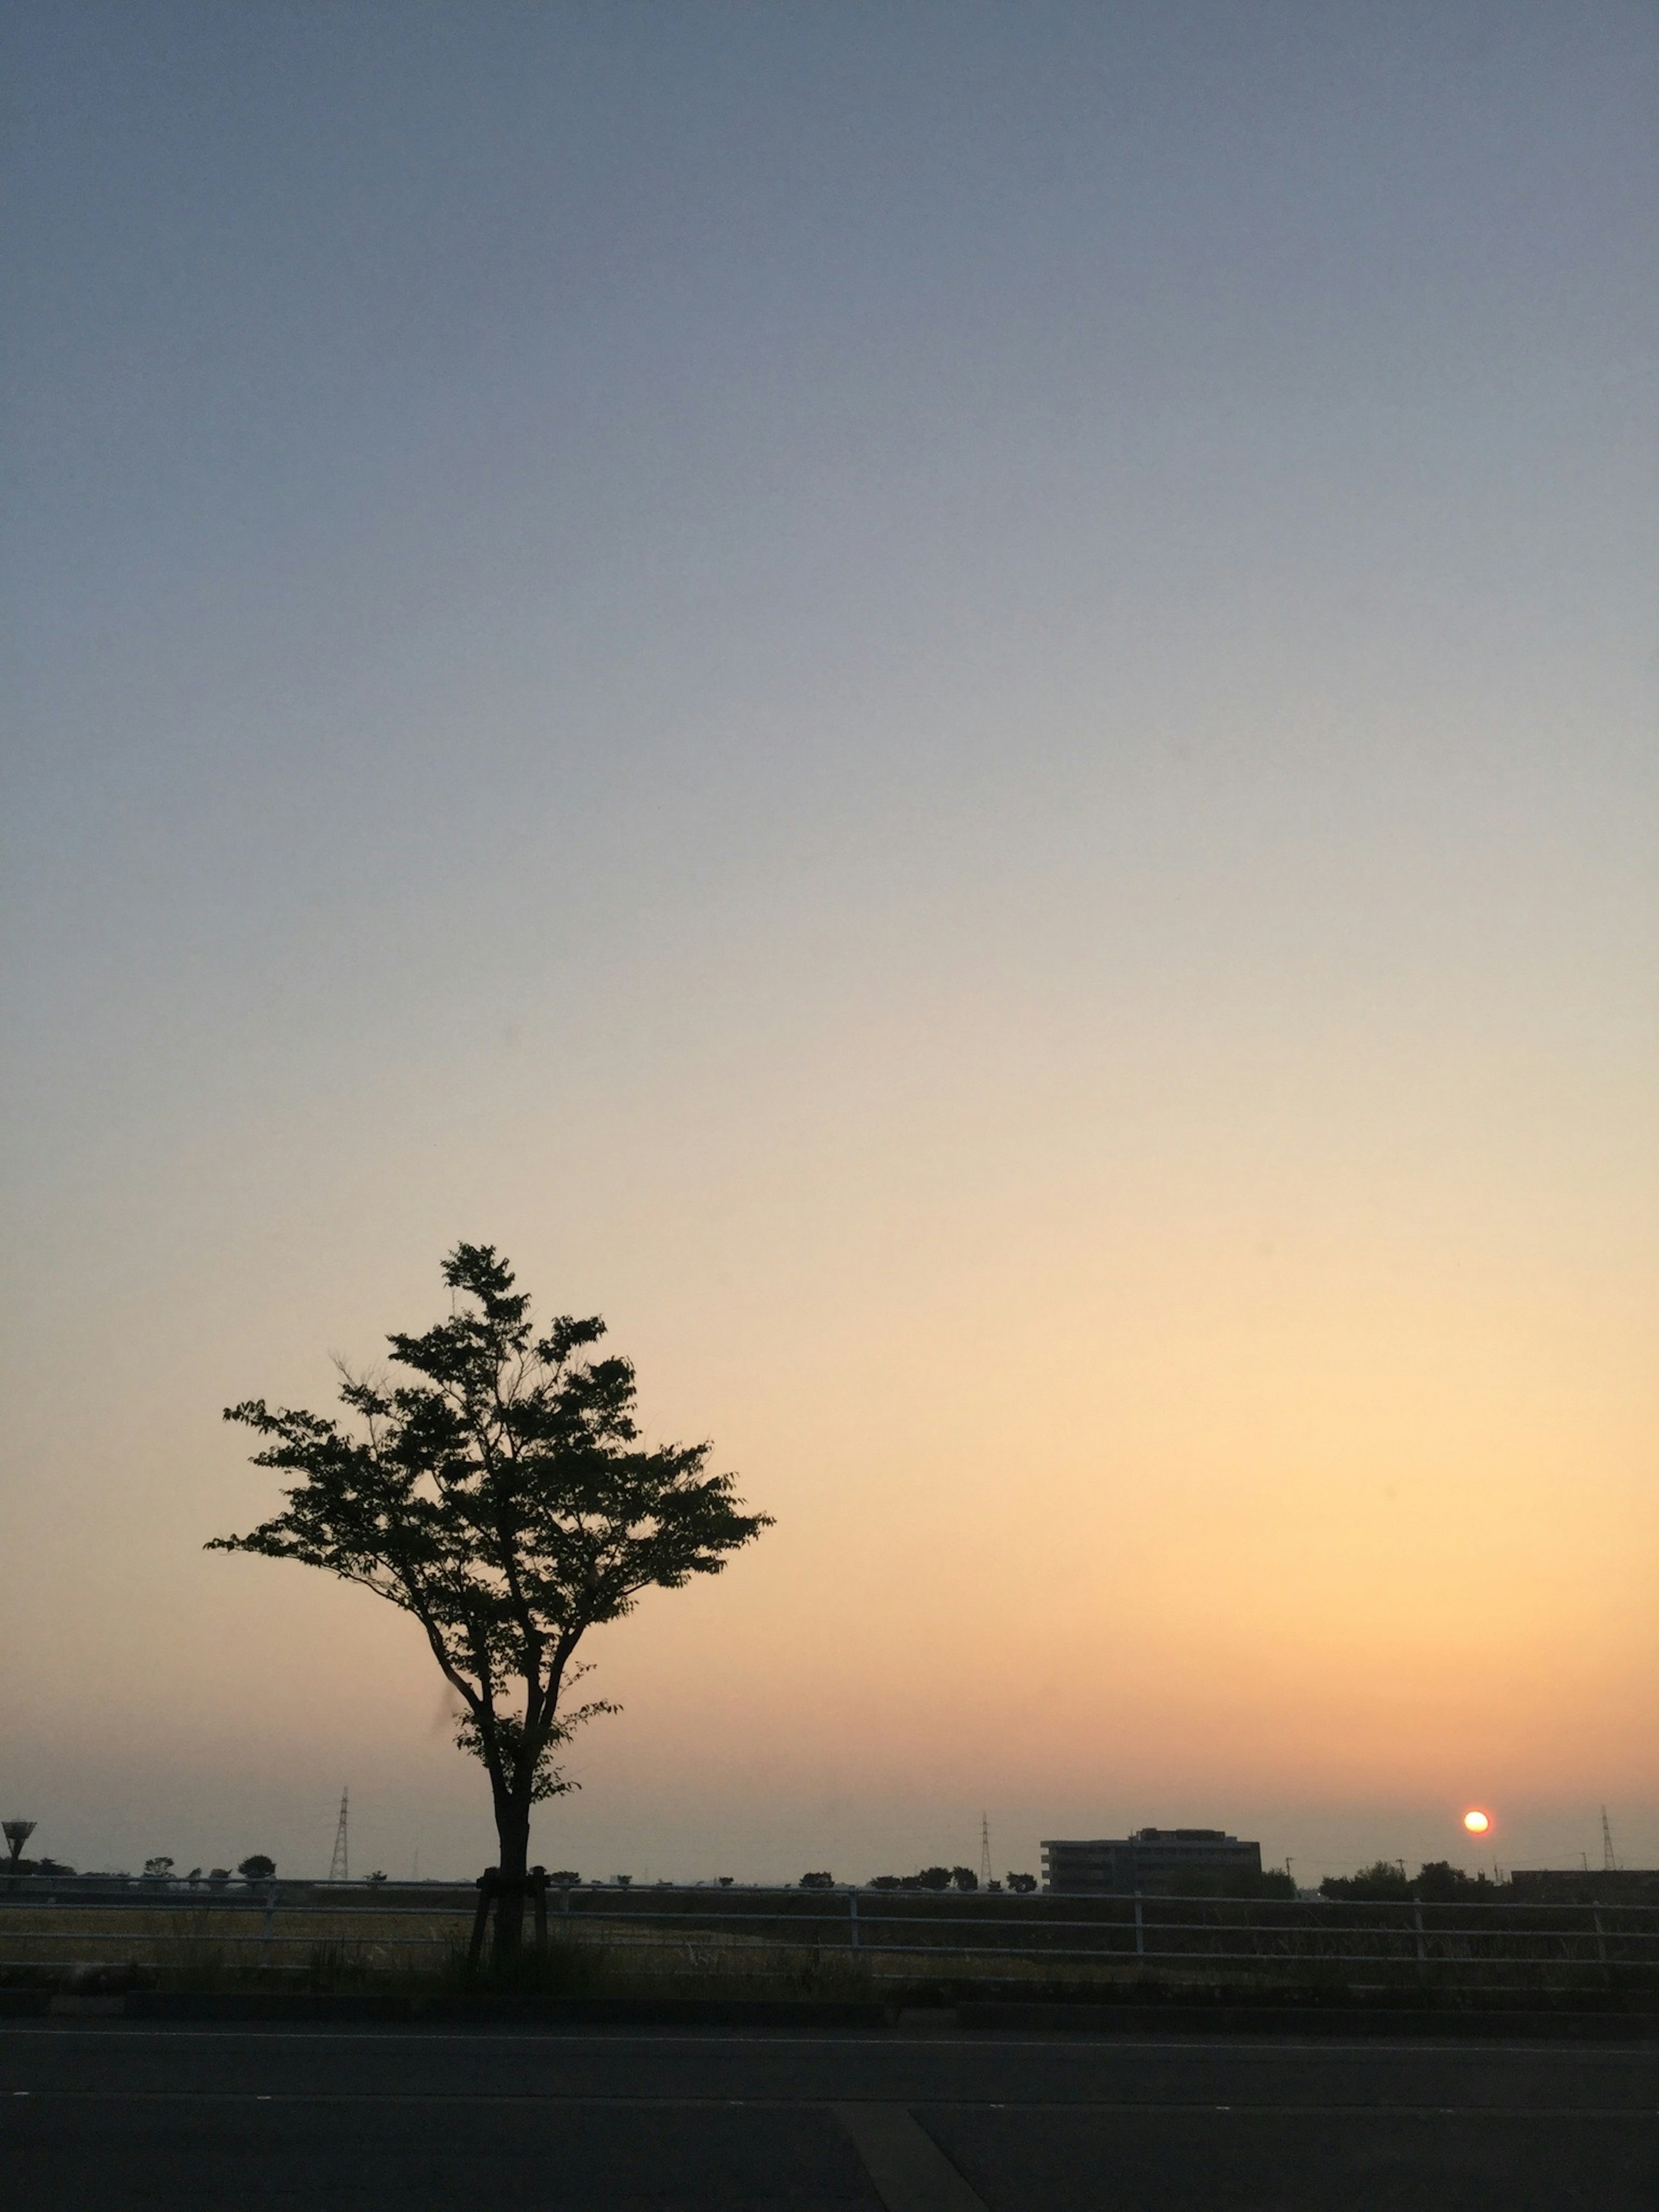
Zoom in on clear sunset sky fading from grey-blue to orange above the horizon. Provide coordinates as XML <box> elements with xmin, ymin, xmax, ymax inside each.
<box><xmin>0</xmin><ymin>0</ymin><xmax>1659</xmax><ymax>1880</ymax></box>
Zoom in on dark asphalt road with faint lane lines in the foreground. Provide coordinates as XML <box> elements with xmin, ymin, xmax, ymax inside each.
<box><xmin>0</xmin><ymin>2022</ymin><xmax>1659</xmax><ymax>2212</ymax></box>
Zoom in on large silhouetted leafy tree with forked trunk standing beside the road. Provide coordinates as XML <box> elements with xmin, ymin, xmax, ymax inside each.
<box><xmin>208</xmin><ymin>1243</ymin><xmax>770</xmax><ymax>1951</ymax></box>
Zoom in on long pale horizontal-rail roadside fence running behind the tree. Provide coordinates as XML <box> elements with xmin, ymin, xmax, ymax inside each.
<box><xmin>0</xmin><ymin>1878</ymin><xmax>1659</xmax><ymax>1986</ymax></box>
